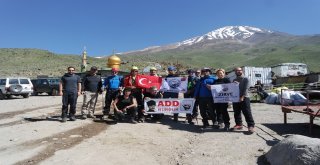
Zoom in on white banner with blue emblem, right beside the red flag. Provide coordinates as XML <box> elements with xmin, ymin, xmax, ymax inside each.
<box><xmin>160</xmin><ymin>77</ymin><xmax>188</xmax><ymax>93</ymax></box>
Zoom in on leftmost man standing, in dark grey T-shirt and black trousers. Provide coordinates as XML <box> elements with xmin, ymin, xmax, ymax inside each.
<box><xmin>59</xmin><ymin>66</ymin><xmax>81</xmax><ymax>122</ymax></box>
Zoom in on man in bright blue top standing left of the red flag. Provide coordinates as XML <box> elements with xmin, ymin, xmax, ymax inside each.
<box><xmin>102</xmin><ymin>68</ymin><xmax>123</xmax><ymax>120</ymax></box>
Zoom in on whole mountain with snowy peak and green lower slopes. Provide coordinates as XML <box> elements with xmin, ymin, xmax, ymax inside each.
<box><xmin>121</xmin><ymin>26</ymin><xmax>320</xmax><ymax>72</ymax></box>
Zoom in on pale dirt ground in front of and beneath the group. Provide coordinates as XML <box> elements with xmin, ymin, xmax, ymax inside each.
<box><xmin>0</xmin><ymin>96</ymin><xmax>319</xmax><ymax>165</ymax></box>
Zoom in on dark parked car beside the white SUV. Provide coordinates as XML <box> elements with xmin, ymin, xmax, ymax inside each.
<box><xmin>31</xmin><ymin>77</ymin><xmax>60</xmax><ymax>96</ymax></box>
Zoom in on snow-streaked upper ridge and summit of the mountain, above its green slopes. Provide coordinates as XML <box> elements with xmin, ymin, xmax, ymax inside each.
<box><xmin>122</xmin><ymin>26</ymin><xmax>274</xmax><ymax>54</ymax></box>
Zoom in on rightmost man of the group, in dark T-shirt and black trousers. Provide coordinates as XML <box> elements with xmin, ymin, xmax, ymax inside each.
<box><xmin>233</xmin><ymin>67</ymin><xmax>254</xmax><ymax>133</ymax></box>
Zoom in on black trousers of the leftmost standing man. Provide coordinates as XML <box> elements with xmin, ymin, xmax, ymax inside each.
<box><xmin>61</xmin><ymin>91</ymin><xmax>78</xmax><ymax>118</ymax></box>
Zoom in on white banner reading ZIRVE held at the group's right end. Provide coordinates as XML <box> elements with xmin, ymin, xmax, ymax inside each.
<box><xmin>210</xmin><ymin>83</ymin><xmax>240</xmax><ymax>103</ymax></box>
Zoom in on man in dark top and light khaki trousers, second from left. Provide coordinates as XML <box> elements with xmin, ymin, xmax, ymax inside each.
<box><xmin>81</xmin><ymin>66</ymin><xmax>102</xmax><ymax>119</ymax></box>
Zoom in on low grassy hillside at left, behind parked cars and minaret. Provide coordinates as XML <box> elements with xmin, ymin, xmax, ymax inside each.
<box><xmin>0</xmin><ymin>48</ymin><xmax>106</xmax><ymax>77</ymax></box>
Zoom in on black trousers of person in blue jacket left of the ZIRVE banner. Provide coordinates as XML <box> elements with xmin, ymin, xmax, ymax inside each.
<box><xmin>199</xmin><ymin>97</ymin><xmax>217</xmax><ymax>122</ymax></box>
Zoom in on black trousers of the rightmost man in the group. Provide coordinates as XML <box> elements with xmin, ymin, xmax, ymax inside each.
<box><xmin>233</xmin><ymin>97</ymin><xmax>254</xmax><ymax>127</ymax></box>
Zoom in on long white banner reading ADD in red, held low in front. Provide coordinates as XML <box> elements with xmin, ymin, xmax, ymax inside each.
<box><xmin>144</xmin><ymin>98</ymin><xmax>195</xmax><ymax>114</ymax></box>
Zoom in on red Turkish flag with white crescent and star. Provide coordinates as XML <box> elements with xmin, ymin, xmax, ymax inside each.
<box><xmin>136</xmin><ymin>74</ymin><xmax>162</xmax><ymax>89</ymax></box>
